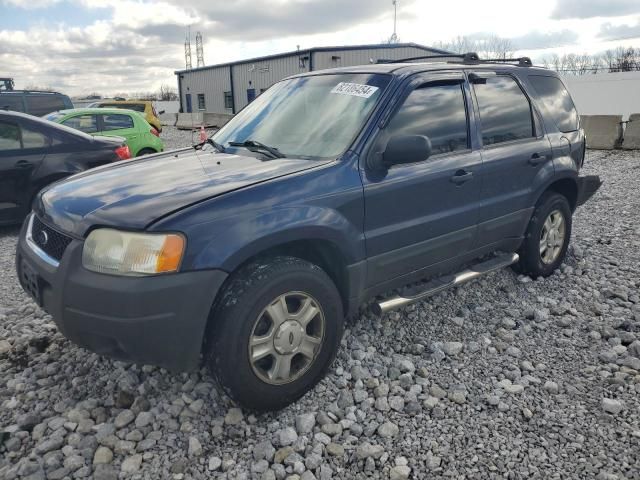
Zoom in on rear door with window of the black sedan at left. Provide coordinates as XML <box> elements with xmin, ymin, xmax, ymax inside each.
<box><xmin>0</xmin><ymin>119</ymin><xmax>50</xmax><ymax>223</ymax></box>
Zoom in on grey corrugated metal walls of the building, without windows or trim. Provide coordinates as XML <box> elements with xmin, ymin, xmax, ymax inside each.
<box><xmin>179</xmin><ymin>46</ymin><xmax>444</xmax><ymax>113</ymax></box>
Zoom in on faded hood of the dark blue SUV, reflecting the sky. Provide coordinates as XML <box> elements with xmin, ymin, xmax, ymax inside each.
<box><xmin>35</xmin><ymin>148</ymin><xmax>328</xmax><ymax>237</ymax></box>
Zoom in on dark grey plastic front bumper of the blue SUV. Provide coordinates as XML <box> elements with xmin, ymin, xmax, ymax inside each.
<box><xmin>16</xmin><ymin>218</ymin><xmax>227</xmax><ymax>371</ymax></box>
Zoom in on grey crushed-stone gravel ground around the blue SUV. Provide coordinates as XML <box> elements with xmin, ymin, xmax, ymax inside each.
<box><xmin>0</xmin><ymin>147</ymin><xmax>640</xmax><ymax>480</ymax></box>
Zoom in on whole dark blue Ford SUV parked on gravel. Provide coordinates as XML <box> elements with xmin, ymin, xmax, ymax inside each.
<box><xmin>16</xmin><ymin>54</ymin><xmax>600</xmax><ymax>410</ymax></box>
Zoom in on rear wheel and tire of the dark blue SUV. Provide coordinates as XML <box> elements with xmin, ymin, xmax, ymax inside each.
<box><xmin>516</xmin><ymin>192</ymin><xmax>572</xmax><ymax>278</ymax></box>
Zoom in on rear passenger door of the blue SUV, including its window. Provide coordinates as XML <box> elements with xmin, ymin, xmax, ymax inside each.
<box><xmin>469</xmin><ymin>71</ymin><xmax>553</xmax><ymax>247</ymax></box>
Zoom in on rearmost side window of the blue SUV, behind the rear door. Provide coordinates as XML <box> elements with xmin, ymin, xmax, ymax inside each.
<box><xmin>529</xmin><ymin>75</ymin><xmax>578</xmax><ymax>132</ymax></box>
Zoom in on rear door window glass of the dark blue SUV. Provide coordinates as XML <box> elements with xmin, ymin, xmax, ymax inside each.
<box><xmin>473</xmin><ymin>76</ymin><xmax>534</xmax><ymax>146</ymax></box>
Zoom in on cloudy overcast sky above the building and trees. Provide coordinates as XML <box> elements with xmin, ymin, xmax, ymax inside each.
<box><xmin>0</xmin><ymin>0</ymin><xmax>640</xmax><ymax>95</ymax></box>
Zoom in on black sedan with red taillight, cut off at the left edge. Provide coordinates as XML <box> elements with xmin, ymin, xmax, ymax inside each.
<box><xmin>0</xmin><ymin>111</ymin><xmax>130</xmax><ymax>225</ymax></box>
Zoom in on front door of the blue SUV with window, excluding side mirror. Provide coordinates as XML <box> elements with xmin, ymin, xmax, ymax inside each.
<box><xmin>361</xmin><ymin>73</ymin><xmax>482</xmax><ymax>287</ymax></box>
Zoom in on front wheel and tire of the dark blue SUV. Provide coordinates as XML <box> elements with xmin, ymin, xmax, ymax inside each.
<box><xmin>206</xmin><ymin>257</ymin><xmax>344</xmax><ymax>411</ymax></box>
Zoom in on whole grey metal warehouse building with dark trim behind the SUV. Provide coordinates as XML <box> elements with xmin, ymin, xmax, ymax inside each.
<box><xmin>175</xmin><ymin>43</ymin><xmax>449</xmax><ymax>114</ymax></box>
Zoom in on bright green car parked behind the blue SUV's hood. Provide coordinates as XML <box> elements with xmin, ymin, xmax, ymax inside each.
<box><xmin>44</xmin><ymin>108</ymin><xmax>164</xmax><ymax>157</ymax></box>
